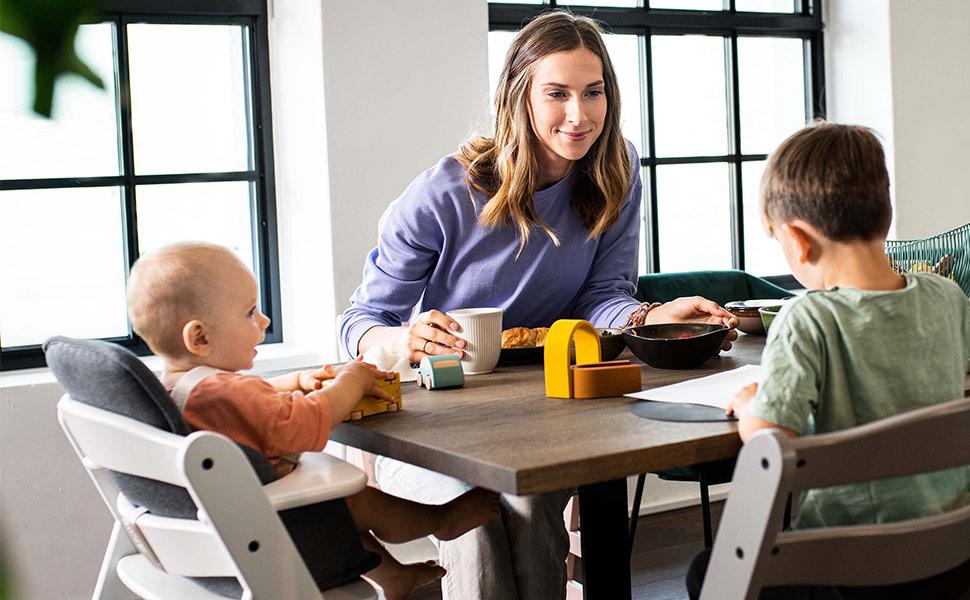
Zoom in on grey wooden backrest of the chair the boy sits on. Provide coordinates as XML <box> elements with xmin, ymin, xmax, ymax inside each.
<box><xmin>701</xmin><ymin>398</ymin><xmax>970</xmax><ymax>600</ymax></box>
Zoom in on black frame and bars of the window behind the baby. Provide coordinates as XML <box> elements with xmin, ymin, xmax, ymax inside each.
<box><xmin>0</xmin><ymin>0</ymin><xmax>283</xmax><ymax>371</ymax></box>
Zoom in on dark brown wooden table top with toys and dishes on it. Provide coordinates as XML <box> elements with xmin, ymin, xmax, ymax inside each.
<box><xmin>331</xmin><ymin>334</ymin><xmax>765</xmax><ymax>495</ymax></box>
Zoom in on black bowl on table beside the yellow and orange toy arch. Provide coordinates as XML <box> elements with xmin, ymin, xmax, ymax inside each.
<box><xmin>623</xmin><ymin>323</ymin><xmax>728</xmax><ymax>369</ymax></box>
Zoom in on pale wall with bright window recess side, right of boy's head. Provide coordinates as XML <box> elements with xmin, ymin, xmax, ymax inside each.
<box><xmin>825</xmin><ymin>0</ymin><xmax>970</xmax><ymax>239</ymax></box>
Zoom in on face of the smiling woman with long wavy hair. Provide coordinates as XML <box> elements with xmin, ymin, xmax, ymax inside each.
<box><xmin>529</xmin><ymin>48</ymin><xmax>607</xmax><ymax>176</ymax></box>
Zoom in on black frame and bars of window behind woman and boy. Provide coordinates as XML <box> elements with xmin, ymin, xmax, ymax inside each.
<box><xmin>488</xmin><ymin>0</ymin><xmax>826</xmax><ymax>289</ymax></box>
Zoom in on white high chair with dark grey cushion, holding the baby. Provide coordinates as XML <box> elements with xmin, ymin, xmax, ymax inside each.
<box><xmin>44</xmin><ymin>338</ymin><xmax>379</xmax><ymax>600</ymax></box>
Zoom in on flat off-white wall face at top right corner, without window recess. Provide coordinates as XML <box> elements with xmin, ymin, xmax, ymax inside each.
<box><xmin>889</xmin><ymin>0</ymin><xmax>970</xmax><ymax>239</ymax></box>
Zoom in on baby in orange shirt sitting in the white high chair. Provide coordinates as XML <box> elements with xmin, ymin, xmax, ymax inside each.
<box><xmin>128</xmin><ymin>242</ymin><xmax>498</xmax><ymax>600</ymax></box>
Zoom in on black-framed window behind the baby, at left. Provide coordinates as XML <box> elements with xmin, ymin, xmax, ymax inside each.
<box><xmin>0</xmin><ymin>0</ymin><xmax>281</xmax><ymax>370</ymax></box>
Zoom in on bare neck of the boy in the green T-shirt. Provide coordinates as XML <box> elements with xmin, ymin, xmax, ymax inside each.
<box><xmin>818</xmin><ymin>239</ymin><xmax>906</xmax><ymax>291</ymax></box>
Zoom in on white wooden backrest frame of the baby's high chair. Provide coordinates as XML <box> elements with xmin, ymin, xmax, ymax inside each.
<box><xmin>58</xmin><ymin>395</ymin><xmax>319</xmax><ymax>598</ymax></box>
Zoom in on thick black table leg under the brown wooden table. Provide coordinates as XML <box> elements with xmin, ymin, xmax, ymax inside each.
<box><xmin>579</xmin><ymin>479</ymin><xmax>632</xmax><ymax>600</ymax></box>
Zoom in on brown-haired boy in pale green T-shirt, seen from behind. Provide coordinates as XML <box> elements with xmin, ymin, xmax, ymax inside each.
<box><xmin>688</xmin><ymin>123</ymin><xmax>970</xmax><ymax>598</ymax></box>
